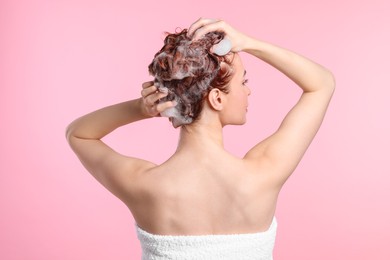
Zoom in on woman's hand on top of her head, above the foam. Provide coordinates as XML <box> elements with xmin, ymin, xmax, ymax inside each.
<box><xmin>187</xmin><ymin>18</ymin><xmax>250</xmax><ymax>52</ymax></box>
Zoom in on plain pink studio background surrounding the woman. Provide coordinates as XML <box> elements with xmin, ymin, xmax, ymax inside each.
<box><xmin>0</xmin><ymin>0</ymin><xmax>390</xmax><ymax>260</ymax></box>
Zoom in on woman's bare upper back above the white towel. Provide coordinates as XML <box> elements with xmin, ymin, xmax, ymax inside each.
<box><xmin>130</xmin><ymin>149</ymin><xmax>278</xmax><ymax>235</ymax></box>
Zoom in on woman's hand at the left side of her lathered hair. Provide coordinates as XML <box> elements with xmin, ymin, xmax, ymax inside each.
<box><xmin>141</xmin><ymin>81</ymin><xmax>176</xmax><ymax>117</ymax></box>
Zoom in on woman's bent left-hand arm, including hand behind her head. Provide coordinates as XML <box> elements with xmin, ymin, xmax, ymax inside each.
<box><xmin>66</xmin><ymin>82</ymin><xmax>172</xmax><ymax>198</ymax></box>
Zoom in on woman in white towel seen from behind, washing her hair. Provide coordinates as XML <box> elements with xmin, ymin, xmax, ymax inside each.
<box><xmin>66</xmin><ymin>19</ymin><xmax>335</xmax><ymax>260</ymax></box>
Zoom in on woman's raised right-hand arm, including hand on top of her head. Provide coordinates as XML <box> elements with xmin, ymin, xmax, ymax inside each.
<box><xmin>189</xmin><ymin>19</ymin><xmax>335</xmax><ymax>186</ymax></box>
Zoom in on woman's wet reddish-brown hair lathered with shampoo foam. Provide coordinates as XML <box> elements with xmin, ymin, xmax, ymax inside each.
<box><xmin>149</xmin><ymin>29</ymin><xmax>233</xmax><ymax>127</ymax></box>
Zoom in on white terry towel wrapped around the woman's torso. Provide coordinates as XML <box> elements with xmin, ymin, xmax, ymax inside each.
<box><xmin>136</xmin><ymin>217</ymin><xmax>277</xmax><ymax>260</ymax></box>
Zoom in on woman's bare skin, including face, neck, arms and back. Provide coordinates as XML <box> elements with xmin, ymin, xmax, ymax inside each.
<box><xmin>67</xmin><ymin>19</ymin><xmax>335</xmax><ymax>235</ymax></box>
